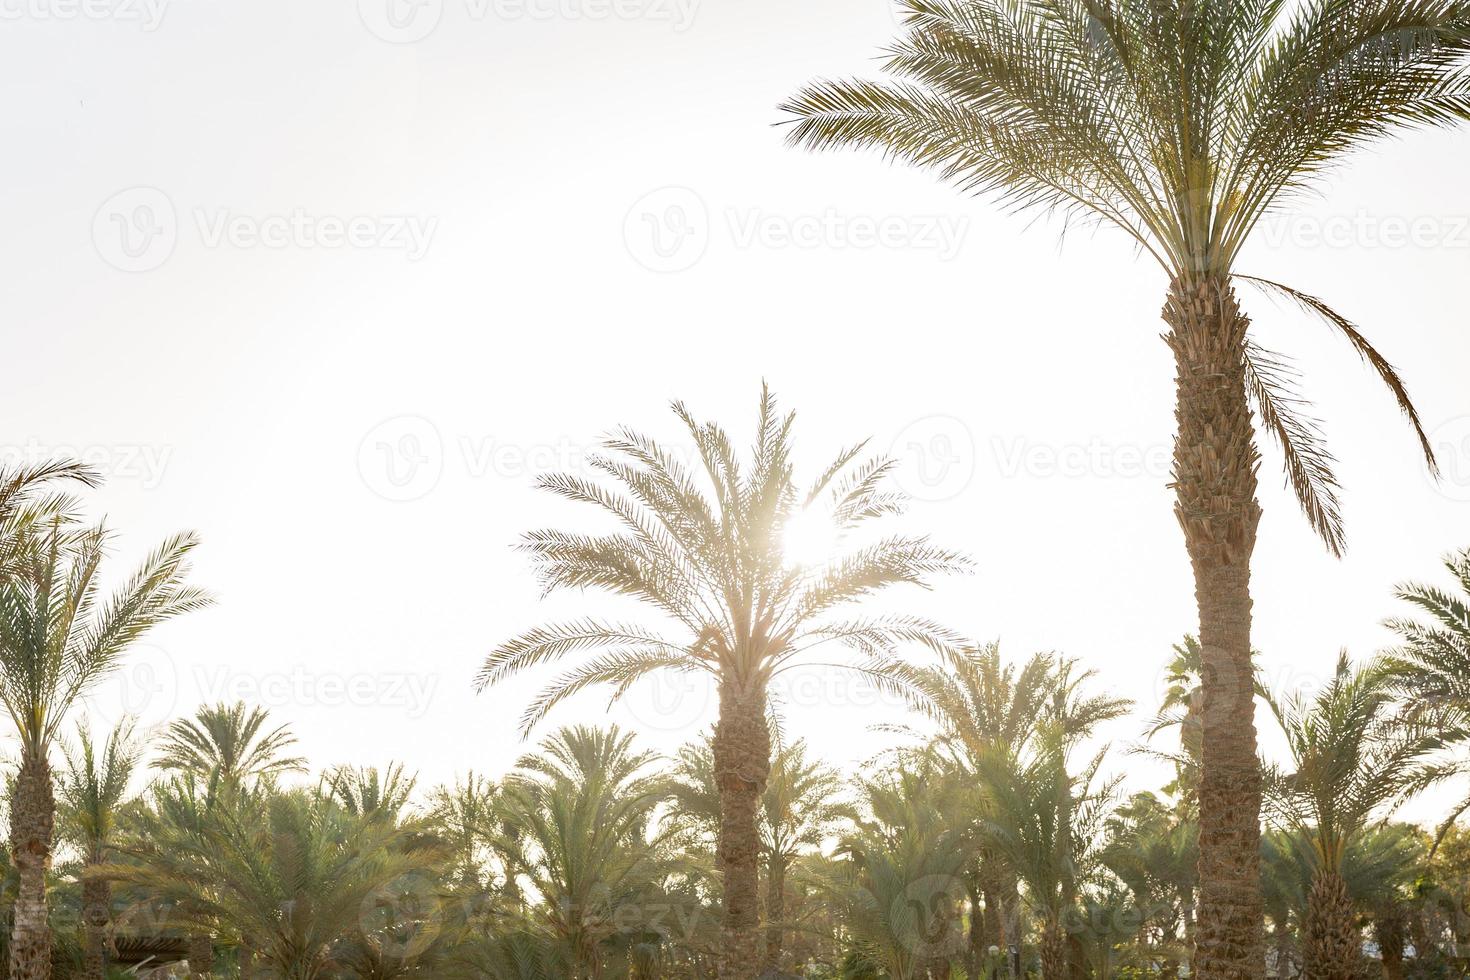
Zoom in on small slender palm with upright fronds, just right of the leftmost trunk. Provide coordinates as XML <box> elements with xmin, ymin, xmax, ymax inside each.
<box><xmin>57</xmin><ymin>721</ymin><xmax>143</xmax><ymax>980</ymax></box>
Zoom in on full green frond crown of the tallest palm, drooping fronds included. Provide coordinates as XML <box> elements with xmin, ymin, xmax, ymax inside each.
<box><xmin>781</xmin><ymin>0</ymin><xmax>1470</xmax><ymax>554</ymax></box>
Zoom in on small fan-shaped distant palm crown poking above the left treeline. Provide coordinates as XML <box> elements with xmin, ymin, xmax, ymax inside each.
<box><xmin>153</xmin><ymin>701</ymin><xmax>304</xmax><ymax>785</ymax></box>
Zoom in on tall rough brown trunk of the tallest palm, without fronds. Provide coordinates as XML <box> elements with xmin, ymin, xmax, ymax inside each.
<box><xmin>1163</xmin><ymin>278</ymin><xmax>1266</xmax><ymax>980</ymax></box>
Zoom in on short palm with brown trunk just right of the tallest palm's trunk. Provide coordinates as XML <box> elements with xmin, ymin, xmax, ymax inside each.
<box><xmin>1269</xmin><ymin>654</ymin><xmax>1444</xmax><ymax>980</ymax></box>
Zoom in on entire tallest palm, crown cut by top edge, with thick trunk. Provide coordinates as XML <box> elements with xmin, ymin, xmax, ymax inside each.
<box><xmin>784</xmin><ymin>0</ymin><xmax>1470</xmax><ymax>980</ymax></box>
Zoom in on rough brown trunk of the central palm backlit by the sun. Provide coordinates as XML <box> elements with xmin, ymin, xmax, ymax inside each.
<box><xmin>714</xmin><ymin>677</ymin><xmax>770</xmax><ymax>980</ymax></box>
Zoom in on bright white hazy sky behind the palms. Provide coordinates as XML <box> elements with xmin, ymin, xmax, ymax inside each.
<box><xmin>0</xmin><ymin>0</ymin><xmax>1470</xmax><ymax>828</ymax></box>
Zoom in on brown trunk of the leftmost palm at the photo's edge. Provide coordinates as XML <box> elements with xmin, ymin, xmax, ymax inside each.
<box><xmin>10</xmin><ymin>752</ymin><xmax>56</xmax><ymax>980</ymax></box>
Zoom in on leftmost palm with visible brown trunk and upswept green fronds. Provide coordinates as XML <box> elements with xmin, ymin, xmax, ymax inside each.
<box><xmin>0</xmin><ymin>516</ymin><xmax>209</xmax><ymax>980</ymax></box>
